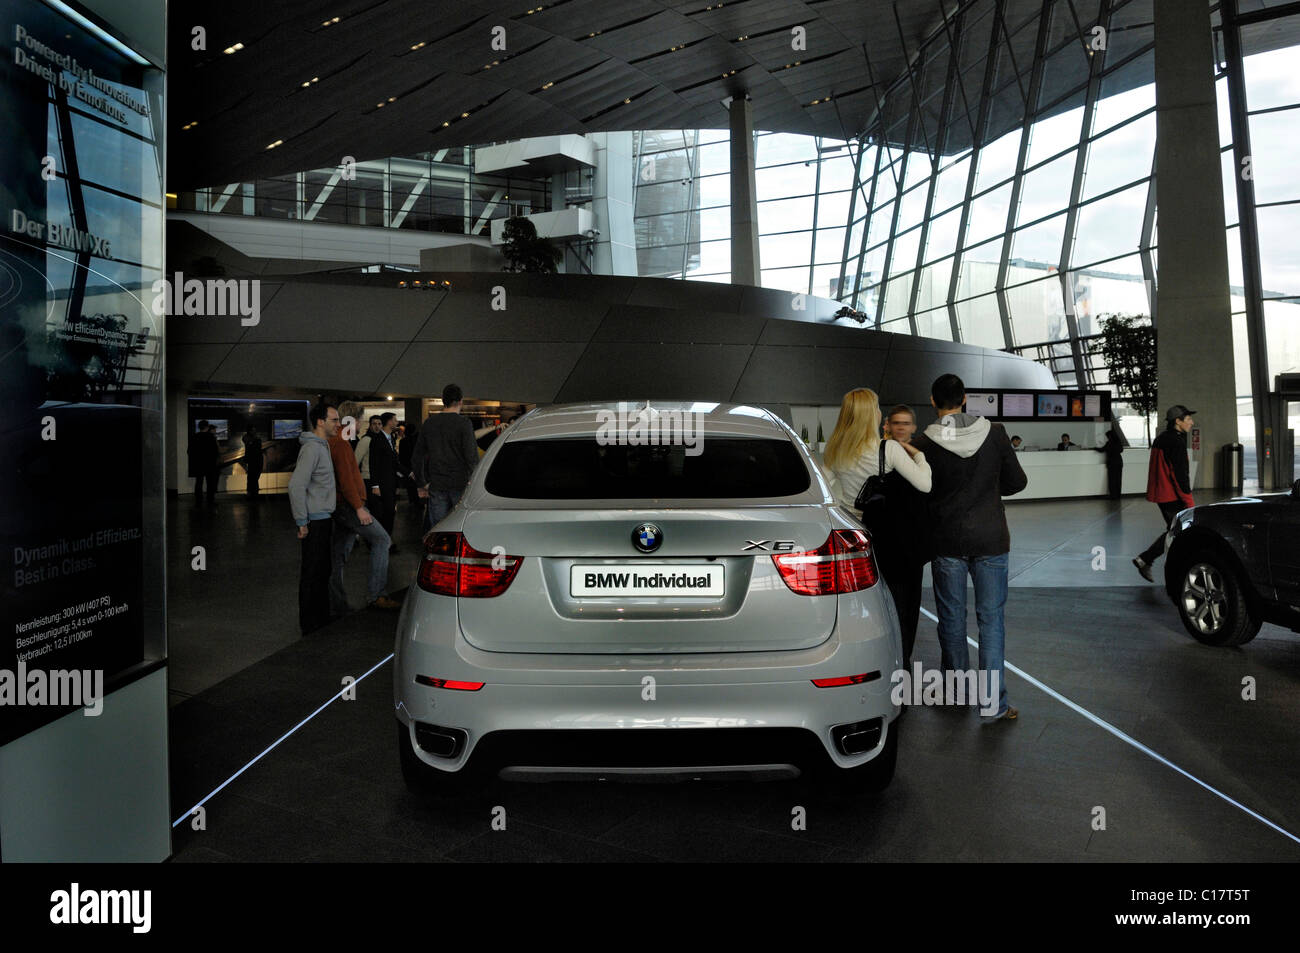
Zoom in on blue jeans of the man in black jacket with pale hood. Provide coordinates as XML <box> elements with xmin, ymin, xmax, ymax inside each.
<box><xmin>930</xmin><ymin>553</ymin><xmax>1008</xmax><ymax>715</ymax></box>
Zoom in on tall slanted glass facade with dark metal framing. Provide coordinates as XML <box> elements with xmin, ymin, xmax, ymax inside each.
<box><xmin>636</xmin><ymin>0</ymin><xmax>1300</xmax><ymax>473</ymax></box>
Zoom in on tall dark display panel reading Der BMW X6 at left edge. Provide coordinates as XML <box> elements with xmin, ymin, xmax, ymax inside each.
<box><xmin>0</xmin><ymin>0</ymin><xmax>166</xmax><ymax>744</ymax></box>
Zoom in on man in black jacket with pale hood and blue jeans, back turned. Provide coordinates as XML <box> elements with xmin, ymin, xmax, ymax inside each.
<box><xmin>913</xmin><ymin>374</ymin><xmax>1030</xmax><ymax>720</ymax></box>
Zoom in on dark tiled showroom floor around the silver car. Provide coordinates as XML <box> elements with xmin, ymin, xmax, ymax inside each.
<box><xmin>170</xmin><ymin>498</ymin><xmax>1300</xmax><ymax>862</ymax></box>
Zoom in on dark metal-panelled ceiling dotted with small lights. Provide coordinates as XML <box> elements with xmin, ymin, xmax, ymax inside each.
<box><xmin>168</xmin><ymin>0</ymin><xmax>972</xmax><ymax>190</ymax></box>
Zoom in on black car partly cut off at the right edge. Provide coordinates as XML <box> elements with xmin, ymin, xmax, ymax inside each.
<box><xmin>1165</xmin><ymin>480</ymin><xmax>1300</xmax><ymax>645</ymax></box>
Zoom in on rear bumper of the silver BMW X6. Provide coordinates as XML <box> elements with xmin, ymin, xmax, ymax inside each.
<box><xmin>394</xmin><ymin>585</ymin><xmax>902</xmax><ymax>771</ymax></box>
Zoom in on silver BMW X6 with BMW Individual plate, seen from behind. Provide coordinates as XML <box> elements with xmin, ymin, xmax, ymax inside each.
<box><xmin>394</xmin><ymin>402</ymin><xmax>902</xmax><ymax>794</ymax></box>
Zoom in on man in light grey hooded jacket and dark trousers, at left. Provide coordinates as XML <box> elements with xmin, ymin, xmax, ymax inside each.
<box><xmin>289</xmin><ymin>402</ymin><xmax>339</xmax><ymax>636</ymax></box>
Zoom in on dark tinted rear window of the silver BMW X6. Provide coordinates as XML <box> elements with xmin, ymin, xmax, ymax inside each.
<box><xmin>486</xmin><ymin>437</ymin><xmax>811</xmax><ymax>499</ymax></box>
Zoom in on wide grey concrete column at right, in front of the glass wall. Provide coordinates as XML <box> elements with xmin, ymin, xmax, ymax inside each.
<box><xmin>1154</xmin><ymin>0</ymin><xmax>1236</xmax><ymax>488</ymax></box>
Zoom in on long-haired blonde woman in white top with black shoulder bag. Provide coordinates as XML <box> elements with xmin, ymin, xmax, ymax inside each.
<box><xmin>824</xmin><ymin>387</ymin><xmax>931</xmax><ymax>666</ymax></box>
